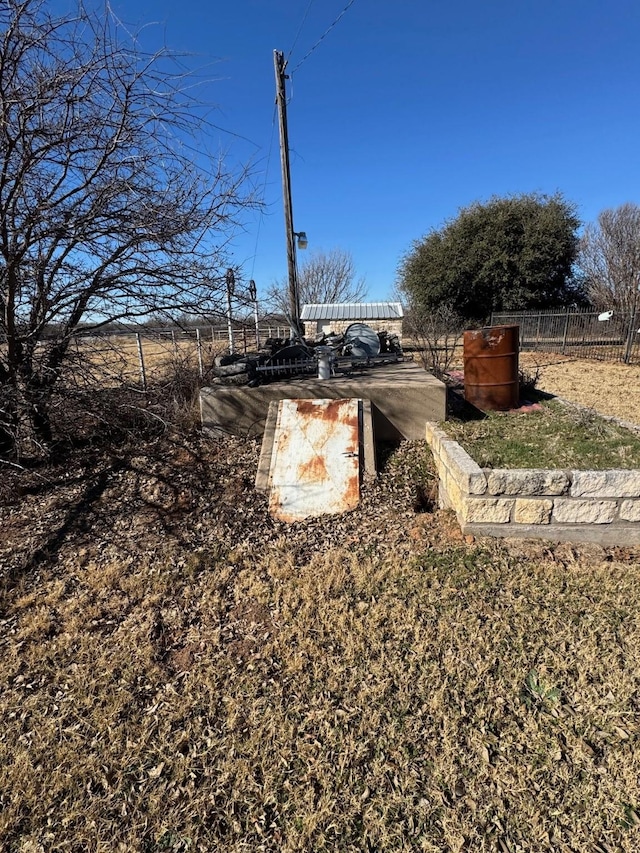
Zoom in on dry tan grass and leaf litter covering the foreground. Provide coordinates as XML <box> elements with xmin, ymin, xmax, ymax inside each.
<box><xmin>0</xmin><ymin>441</ymin><xmax>640</xmax><ymax>853</ymax></box>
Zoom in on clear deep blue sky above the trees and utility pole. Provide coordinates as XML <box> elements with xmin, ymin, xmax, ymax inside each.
<box><xmin>60</xmin><ymin>0</ymin><xmax>640</xmax><ymax>299</ymax></box>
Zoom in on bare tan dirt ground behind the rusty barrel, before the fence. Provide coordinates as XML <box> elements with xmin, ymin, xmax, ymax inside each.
<box><xmin>520</xmin><ymin>352</ymin><xmax>640</xmax><ymax>424</ymax></box>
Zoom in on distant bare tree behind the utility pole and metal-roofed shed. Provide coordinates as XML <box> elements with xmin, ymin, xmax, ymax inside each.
<box><xmin>267</xmin><ymin>249</ymin><xmax>367</xmax><ymax>314</ymax></box>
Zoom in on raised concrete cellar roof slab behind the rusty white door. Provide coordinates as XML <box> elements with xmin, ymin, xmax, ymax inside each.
<box><xmin>200</xmin><ymin>361</ymin><xmax>446</xmax><ymax>442</ymax></box>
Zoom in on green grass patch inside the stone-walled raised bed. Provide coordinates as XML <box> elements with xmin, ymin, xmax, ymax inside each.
<box><xmin>444</xmin><ymin>400</ymin><xmax>640</xmax><ymax>470</ymax></box>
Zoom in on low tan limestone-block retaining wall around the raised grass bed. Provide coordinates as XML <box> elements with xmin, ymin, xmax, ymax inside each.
<box><xmin>426</xmin><ymin>422</ymin><xmax>640</xmax><ymax>545</ymax></box>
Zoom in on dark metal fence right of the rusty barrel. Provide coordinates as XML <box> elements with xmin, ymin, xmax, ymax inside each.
<box><xmin>491</xmin><ymin>308</ymin><xmax>640</xmax><ymax>364</ymax></box>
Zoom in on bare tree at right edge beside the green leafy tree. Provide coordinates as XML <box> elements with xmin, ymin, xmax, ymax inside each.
<box><xmin>578</xmin><ymin>203</ymin><xmax>640</xmax><ymax>314</ymax></box>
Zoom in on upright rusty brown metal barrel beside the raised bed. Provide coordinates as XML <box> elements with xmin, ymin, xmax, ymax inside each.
<box><xmin>464</xmin><ymin>326</ymin><xmax>520</xmax><ymax>411</ymax></box>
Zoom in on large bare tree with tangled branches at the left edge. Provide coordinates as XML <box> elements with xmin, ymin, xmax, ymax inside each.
<box><xmin>0</xmin><ymin>0</ymin><xmax>251</xmax><ymax>456</ymax></box>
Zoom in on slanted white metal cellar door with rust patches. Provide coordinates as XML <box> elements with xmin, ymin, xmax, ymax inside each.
<box><xmin>269</xmin><ymin>399</ymin><xmax>360</xmax><ymax>522</ymax></box>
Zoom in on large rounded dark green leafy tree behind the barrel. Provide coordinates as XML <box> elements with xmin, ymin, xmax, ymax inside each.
<box><xmin>398</xmin><ymin>194</ymin><xmax>580</xmax><ymax>321</ymax></box>
